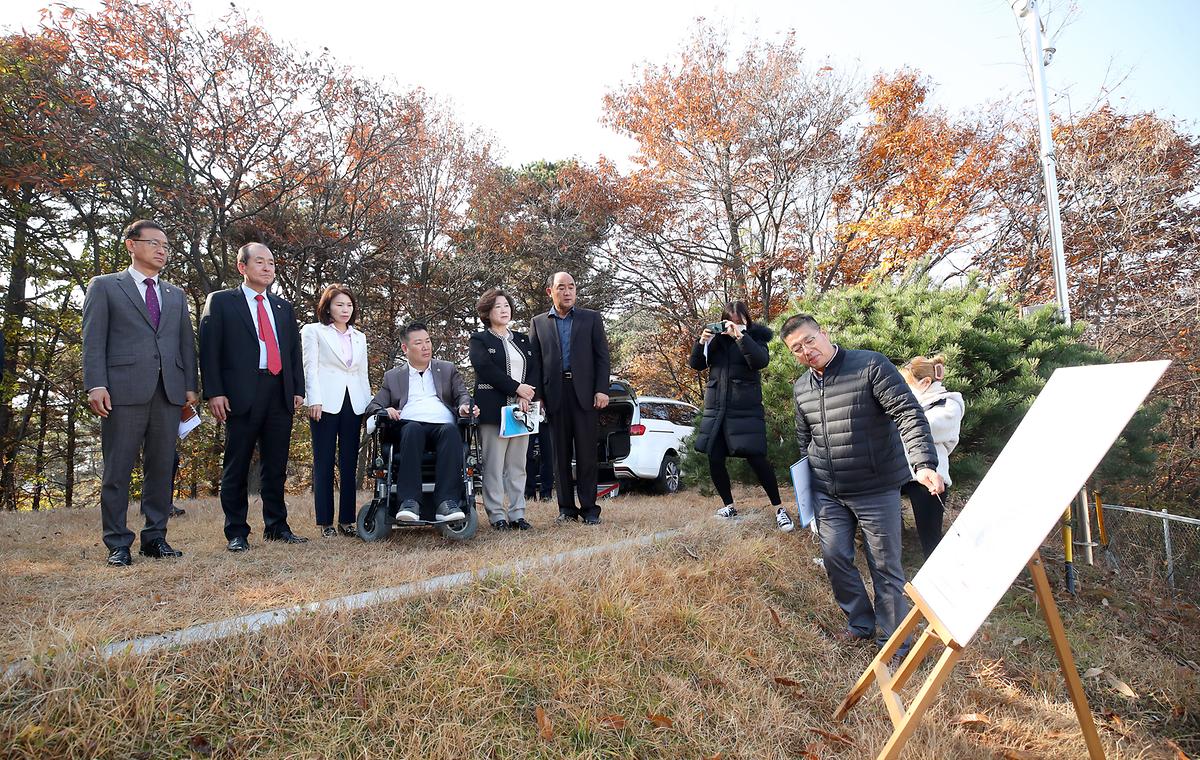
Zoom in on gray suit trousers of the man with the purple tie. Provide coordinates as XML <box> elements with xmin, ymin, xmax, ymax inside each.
<box><xmin>100</xmin><ymin>378</ymin><xmax>181</xmax><ymax>549</ymax></box>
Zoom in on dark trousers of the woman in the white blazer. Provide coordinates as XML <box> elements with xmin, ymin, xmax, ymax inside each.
<box><xmin>308</xmin><ymin>391</ymin><xmax>362</xmax><ymax>526</ymax></box>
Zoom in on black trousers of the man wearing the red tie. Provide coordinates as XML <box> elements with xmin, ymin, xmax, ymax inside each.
<box><xmin>221</xmin><ymin>373</ymin><xmax>294</xmax><ymax>539</ymax></box>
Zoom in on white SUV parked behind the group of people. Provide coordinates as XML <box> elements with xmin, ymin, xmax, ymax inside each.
<box><xmin>613</xmin><ymin>396</ymin><xmax>700</xmax><ymax>493</ymax></box>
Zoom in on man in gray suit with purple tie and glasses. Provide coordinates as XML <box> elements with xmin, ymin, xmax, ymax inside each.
<box><xmin>83</xmin><ymin>220</ymin><xmax>197</xmax><ymax>567</ymax></box>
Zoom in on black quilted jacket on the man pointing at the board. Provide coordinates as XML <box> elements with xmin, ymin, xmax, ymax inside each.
<box><xmin>793</xmin><ymin>348</ymin><xmax>937</xmax><ymax>496</ymax></box>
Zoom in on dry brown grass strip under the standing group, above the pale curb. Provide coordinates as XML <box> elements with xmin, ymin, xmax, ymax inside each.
<box><xmin>0</xmin><ymin>482</ymin><xmax>766</xmax><ymax>663</ymax></box>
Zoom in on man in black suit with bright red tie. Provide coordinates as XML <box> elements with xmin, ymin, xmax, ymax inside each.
<box><xmin>200</xmin><ymin>243</ymin><xmax>308</xmax><ymax>551</ymax></box>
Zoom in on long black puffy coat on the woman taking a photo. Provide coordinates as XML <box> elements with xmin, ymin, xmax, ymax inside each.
<box><xmin>688</xmin><ymin>324</ymin><xmax>774</xmax><ymax>456</ymax></box>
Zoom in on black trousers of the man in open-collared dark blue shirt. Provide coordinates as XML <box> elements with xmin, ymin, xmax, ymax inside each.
<box><xmin>548</xmin><ymin>377</ymin><xmax>600</xmax><ymax>519</ymax></box>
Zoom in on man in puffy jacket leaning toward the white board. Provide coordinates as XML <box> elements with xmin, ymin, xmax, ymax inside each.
<box><xmin>780</xmin><ymin>315</ymin><xmax>944</xmax><ymax>654</ymax></box>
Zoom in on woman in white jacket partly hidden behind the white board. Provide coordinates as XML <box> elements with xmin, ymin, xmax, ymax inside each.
<box><xmin>900</xmin><ymin>354</ymin><xmax>966</xmax><ymax>559</ymax></box>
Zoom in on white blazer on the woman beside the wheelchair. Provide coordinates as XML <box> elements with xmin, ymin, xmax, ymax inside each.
<box><xmin>300</xmin><ymin>322</ymin><xmax>371</xmax><ymax>414</ymax></box>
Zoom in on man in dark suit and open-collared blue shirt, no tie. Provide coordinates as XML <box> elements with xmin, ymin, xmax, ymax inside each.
<box><xmin>529</xmin><ymin>271</ymin><xmax>610</xmax><ymax>525</ymax></box>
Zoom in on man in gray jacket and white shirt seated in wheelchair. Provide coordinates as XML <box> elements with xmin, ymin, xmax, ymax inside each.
<box><xmin>366</xmin><ymin>322</ymin><xmax>479</xmax><ymax>522</ymax></box>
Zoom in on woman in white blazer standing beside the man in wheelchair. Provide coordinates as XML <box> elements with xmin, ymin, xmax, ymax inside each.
<box><xmin>300</xmin><ymin>285</ymin><xmax>371</xmax><ymax>538</ymax></box>
